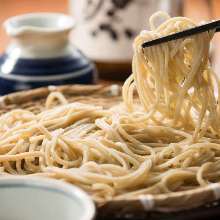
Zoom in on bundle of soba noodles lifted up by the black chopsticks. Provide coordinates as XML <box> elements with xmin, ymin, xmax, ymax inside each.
<box><xmin>123</xmin><ymin>12</ymin><xmax>220</xmax><ymax>140</ymax></box>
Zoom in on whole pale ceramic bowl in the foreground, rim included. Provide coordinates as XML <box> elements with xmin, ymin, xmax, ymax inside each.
<box><xmin>0</xmin><ymin>177</ymin><xmax>95</xmax><ymax>220</ymax></box>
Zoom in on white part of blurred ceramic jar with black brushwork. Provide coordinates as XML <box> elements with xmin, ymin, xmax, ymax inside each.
<box><xmin>69</xmin><ymin>0</ymin><xmax>179</xmax><ymax>63</ymax></box>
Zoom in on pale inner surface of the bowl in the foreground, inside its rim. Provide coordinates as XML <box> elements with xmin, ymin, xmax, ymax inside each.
<box><xmin>0</xmin><ymin>187</ymin><xmax>83</xmax><ymax>220</ymax></box>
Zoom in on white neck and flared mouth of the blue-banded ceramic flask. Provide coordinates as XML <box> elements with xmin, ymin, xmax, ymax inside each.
<box><xmin>4</xmin><ymin>13</ymin><xmax>75</xmax><ymax>59</ymax></box>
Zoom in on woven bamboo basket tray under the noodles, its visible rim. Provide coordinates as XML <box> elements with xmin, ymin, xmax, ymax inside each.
<box><xmin>0</xmin><ymin>85</ymin><xmax>220</xmax><ymax>219</ymax></box>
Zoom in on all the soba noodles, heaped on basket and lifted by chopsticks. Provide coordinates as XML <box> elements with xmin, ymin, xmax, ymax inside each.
<box><xmin>0</xmin><ymin>12</ymin><xmax>220</xmax><ymax>204</ymax></box>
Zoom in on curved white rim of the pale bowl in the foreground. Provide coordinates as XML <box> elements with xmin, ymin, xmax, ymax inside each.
<box><xmin>0</xmin><ymin>176</ymin><xmax>95</xmax><ymax>220</ymax></box>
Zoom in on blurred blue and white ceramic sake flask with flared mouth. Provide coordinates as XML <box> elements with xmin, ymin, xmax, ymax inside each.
<box><xmin>0</xmin><ymin>13</ymin><xmax>96</xmax><ymax>94</ymax></box>
